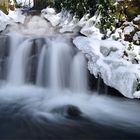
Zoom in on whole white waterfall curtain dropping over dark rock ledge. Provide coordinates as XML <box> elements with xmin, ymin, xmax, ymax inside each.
<box><xmin>4</xmin><ymin>33</ymin><xmax>87</xmax><ymax>91</ymax></box>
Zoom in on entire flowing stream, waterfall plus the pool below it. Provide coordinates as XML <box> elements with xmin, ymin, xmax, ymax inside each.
<box><xmin>0</xmin><ymin>14</ymin><xmax>140</xmax><ymax>139</ymax></box>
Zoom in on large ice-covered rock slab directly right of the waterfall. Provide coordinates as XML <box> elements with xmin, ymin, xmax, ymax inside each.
<box><xmin>73</xmin><ymin>37</ymin><xmax>140</xmax><ymax>98</ymax></box>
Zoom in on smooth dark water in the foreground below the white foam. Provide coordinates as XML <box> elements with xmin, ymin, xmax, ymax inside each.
<box><xmin>0</xmin><ymin>97</ymin><xmax>140</xmax><ymax>140</ymax></box>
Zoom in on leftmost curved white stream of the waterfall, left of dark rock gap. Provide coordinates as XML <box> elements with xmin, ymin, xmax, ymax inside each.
<box><xmin>8</xmin><ymin>39</ymin><xmax>32</xmax><ymax>85</ymax></box>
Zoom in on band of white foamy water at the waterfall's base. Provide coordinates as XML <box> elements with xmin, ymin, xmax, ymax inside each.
<box><xmin>0</xmin><ymin>86</ymin><xmax>140</xmax><ymax>131</ymax></box>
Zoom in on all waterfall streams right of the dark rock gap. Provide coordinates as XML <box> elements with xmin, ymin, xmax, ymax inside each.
<box><xmin>36</xmin><ymin>38</ymin><xmax>87</xmax><ymax>91</ymax></box>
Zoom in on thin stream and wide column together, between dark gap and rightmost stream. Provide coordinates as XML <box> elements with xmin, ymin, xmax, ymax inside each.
<box><xmin>36</xmin><ymin>37</ymin><xmax>75</xmax><ymax>89</ymax></box>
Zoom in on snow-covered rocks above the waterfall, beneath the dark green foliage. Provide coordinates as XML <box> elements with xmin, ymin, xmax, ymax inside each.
<box><xmin>41</xmin><ymin>8</ymin><xmax>88</xmax><ymax>34</ymax></box>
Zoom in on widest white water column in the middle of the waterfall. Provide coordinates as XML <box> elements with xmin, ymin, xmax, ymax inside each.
<box><xmin>49</xmin><ymin>39</ymin><xmax>72</xmax><ymax>89</ymax></box>
